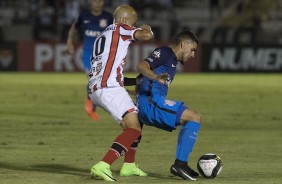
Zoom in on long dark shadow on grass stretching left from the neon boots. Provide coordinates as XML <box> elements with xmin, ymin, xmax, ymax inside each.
<box><xmin>0</xmin><ymin>162</ymin><xmax>90</xmax><ymax>176</ymax></box>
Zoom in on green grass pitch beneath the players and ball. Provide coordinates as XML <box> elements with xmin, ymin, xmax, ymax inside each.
<box><xmin>0</xmin><ymin>72</ymin><xmax>282</xmax><ymax>184</ymax></box>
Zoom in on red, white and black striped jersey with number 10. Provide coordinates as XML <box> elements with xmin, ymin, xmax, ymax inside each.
<box><xmin>89</xmin><ymin>24</ymin><xmax>140</xmax><ymax>91</ymax></box>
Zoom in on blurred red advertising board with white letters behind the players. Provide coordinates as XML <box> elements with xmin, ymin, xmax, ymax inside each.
<box><xmin>18</xmin><ymin>42</ymin><xmax>201</xmax><ymax>72</ymax></box>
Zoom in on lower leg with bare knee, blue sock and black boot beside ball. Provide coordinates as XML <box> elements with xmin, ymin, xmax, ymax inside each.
<box><xmin>171</xmin><ymin>106</ymin><xmax>200</xmax><ymax>180</ymax></box>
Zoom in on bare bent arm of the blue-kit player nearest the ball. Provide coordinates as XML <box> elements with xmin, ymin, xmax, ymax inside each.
<box><xmin>137</xmin><ymin>61</ymin><xmax>169</xmax><ymax>84</ymax></box>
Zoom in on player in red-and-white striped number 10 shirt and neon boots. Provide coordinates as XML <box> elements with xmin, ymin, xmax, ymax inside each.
<box><xmin>89</xmin><ymin>5</ymin><xmax>153</xmax><ymax>181</ymax></box>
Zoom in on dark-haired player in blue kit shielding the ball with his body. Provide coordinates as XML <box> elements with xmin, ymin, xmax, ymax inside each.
<box><xmin>136</xmin><ymin>30</ymin><xmax>200</xmax><ymax>180</ymax></box>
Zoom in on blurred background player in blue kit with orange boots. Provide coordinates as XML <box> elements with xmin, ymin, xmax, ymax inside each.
<box><xmin>66</xmin><ymin>0</ymin><xmax>113</xmax><ymax>120</ymax></box>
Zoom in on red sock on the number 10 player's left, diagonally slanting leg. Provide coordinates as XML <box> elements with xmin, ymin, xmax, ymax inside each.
<box><xmin>102</xmin><ymin>128</ymin><xmax>141</xmax><ymax>165</ymax></box>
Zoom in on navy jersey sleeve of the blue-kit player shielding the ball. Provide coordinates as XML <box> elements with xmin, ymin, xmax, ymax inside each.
<box><xmin>145</xmin><ymin>48</ymin><xmax>171</xmax><ymax>69</ymax></box>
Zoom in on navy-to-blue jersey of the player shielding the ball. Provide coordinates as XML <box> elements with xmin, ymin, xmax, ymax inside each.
<box><xmin>138</xmin><ymin>47</ymin><xmax>178</xmax><ymax>96</ymax></box>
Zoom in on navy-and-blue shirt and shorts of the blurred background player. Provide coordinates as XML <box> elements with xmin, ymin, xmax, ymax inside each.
<box><xmin>75</xmin><ymin>10</ymin><xmax>113</xmax><ymax>70</ymax></box>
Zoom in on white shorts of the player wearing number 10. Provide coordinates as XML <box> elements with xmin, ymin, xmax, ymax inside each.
<box><xmin>89</xmin><ymin>87</ymin><xmax>138</xmax><ymax>123</ymax></box>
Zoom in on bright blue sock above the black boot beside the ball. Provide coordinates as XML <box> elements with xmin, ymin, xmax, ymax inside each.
<box><xmin>176</xmin><ymin>121</ymin><xmax>200</xmax><ymax>162</ymax></box>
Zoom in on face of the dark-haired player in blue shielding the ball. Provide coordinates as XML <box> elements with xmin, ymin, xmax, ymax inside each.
<box><xmin>180</xmin><ymin>40</ymin><xmax>198</xmax><ymax>64</ymax></box>
